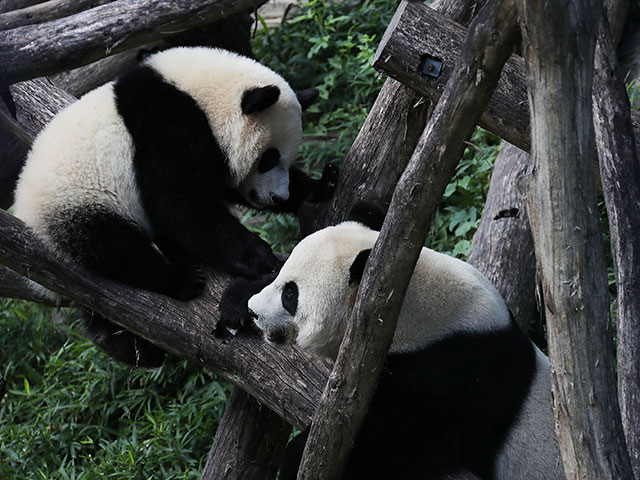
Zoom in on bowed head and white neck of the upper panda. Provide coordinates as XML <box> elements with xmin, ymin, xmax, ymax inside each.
<box><xmin>145</xmin><ymin>47</ymin><xmax>318</xmax><ymax>208</ymax></box>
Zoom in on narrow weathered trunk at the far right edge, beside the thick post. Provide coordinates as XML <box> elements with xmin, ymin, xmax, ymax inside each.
<box><xmin>593</xmin><ymin>15</ymin><xmax>640</xmax><ymax>478</ymax></box>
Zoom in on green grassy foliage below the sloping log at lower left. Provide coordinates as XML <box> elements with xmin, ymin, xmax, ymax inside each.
<box><xmin>0</xmin><ymin>300</ymin><xmax>228</xmax><ymax>480</ymax></box>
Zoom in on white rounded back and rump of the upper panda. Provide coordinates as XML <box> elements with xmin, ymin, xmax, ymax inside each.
<box><xmin>14</xmin><ymin>83</ymin><xmax>144</xmax><ymax>235</ymax></box>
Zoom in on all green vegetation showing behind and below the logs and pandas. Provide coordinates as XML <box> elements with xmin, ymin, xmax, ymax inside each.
<box><xmin>0</xmin><ymin>0</ymin><xmax>640</xmax><ymax>480</ymax></box>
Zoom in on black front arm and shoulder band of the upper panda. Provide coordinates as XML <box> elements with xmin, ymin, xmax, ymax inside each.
<box><xmin>114</xmin><ymin>67</ymin><xmax>279</xmax><ymax>276</ymax></box>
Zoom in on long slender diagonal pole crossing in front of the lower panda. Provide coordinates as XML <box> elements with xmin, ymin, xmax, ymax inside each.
<box><xmin>298</xmin><ymin>0</ymin><xmax>517</xmax><ymax>479</ymax></box>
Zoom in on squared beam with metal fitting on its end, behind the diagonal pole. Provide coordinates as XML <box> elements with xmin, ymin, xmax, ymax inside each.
<box><xmin>373</xmin><ymin>2</ymin><xmax>640</xmax><ymax>159</ymax></box>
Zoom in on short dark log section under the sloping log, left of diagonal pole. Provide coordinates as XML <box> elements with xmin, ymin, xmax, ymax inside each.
<box><xmin>201</xmin><ymin>387</ymin><xmax>291</xmax><ymax>480</ymax></box>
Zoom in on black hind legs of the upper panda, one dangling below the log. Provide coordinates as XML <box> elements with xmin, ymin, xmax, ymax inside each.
<box><xmin>49</xmin><ymin>206</ymin><xmax>204</xmax><ymax>368</ymax></box>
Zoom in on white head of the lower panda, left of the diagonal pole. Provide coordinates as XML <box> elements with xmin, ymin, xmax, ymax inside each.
<box><xmin>248</xmin><ymin>204</ymin><xmax>378</xmax><ymax>358</ymax></box>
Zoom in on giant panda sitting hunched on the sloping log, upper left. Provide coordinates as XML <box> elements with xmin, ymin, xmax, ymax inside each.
<box><xmin>14</xmin><ymin>47</ymin><xmax>337</xmax><ymax>366</ymax></box>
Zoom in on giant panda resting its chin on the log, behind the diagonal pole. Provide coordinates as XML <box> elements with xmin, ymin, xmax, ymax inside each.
<box><xmin>248</xmin><ymin>203</ymin><xmax>564</xmax><ymax>480</ymax></box>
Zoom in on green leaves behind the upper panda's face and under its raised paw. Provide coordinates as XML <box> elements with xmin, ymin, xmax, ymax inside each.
<box><xmin>245</xmin><ymin>0</ymin><xmax>397</xmax><ymax>252</ymax></box>
